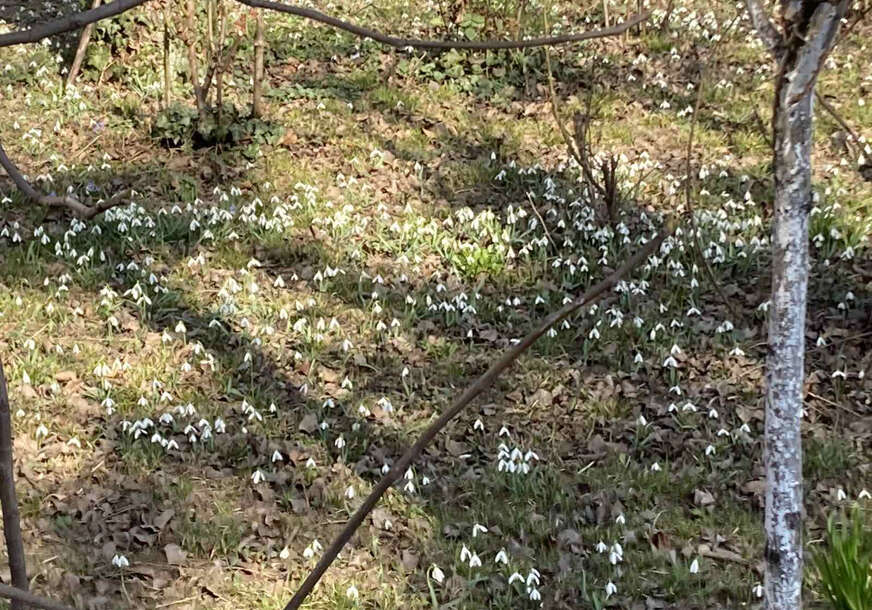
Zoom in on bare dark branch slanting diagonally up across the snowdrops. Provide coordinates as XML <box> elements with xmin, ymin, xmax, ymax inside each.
<box><xmin>284</xmin><ymin>224</ymin><xmax>675</xmax><ymax>610</ymax></box>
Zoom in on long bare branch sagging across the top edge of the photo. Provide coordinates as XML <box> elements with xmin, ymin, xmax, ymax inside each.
<box><xmin>237</xmin><ymin>0</ymin><xmax>651</xmax><ymax>50</ymax></box>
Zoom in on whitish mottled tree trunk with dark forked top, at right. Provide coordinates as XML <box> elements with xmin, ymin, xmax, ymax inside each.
<box><xmin>748</xmin><ymin>0</ymin><xmax>850</xmax><ymax>610</ymax></box>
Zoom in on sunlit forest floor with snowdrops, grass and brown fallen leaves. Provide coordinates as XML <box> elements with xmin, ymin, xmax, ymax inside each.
<box><xmin>0</xmin><ymin>0</ymin><xmax>872</xmax><ymax>610</ymax></box>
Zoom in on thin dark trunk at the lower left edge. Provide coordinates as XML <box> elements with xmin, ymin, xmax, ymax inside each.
<box><xmin>0</xmin><ymin>362</ymin><xmax>28</xmax><ymax>610</ymax></box>
